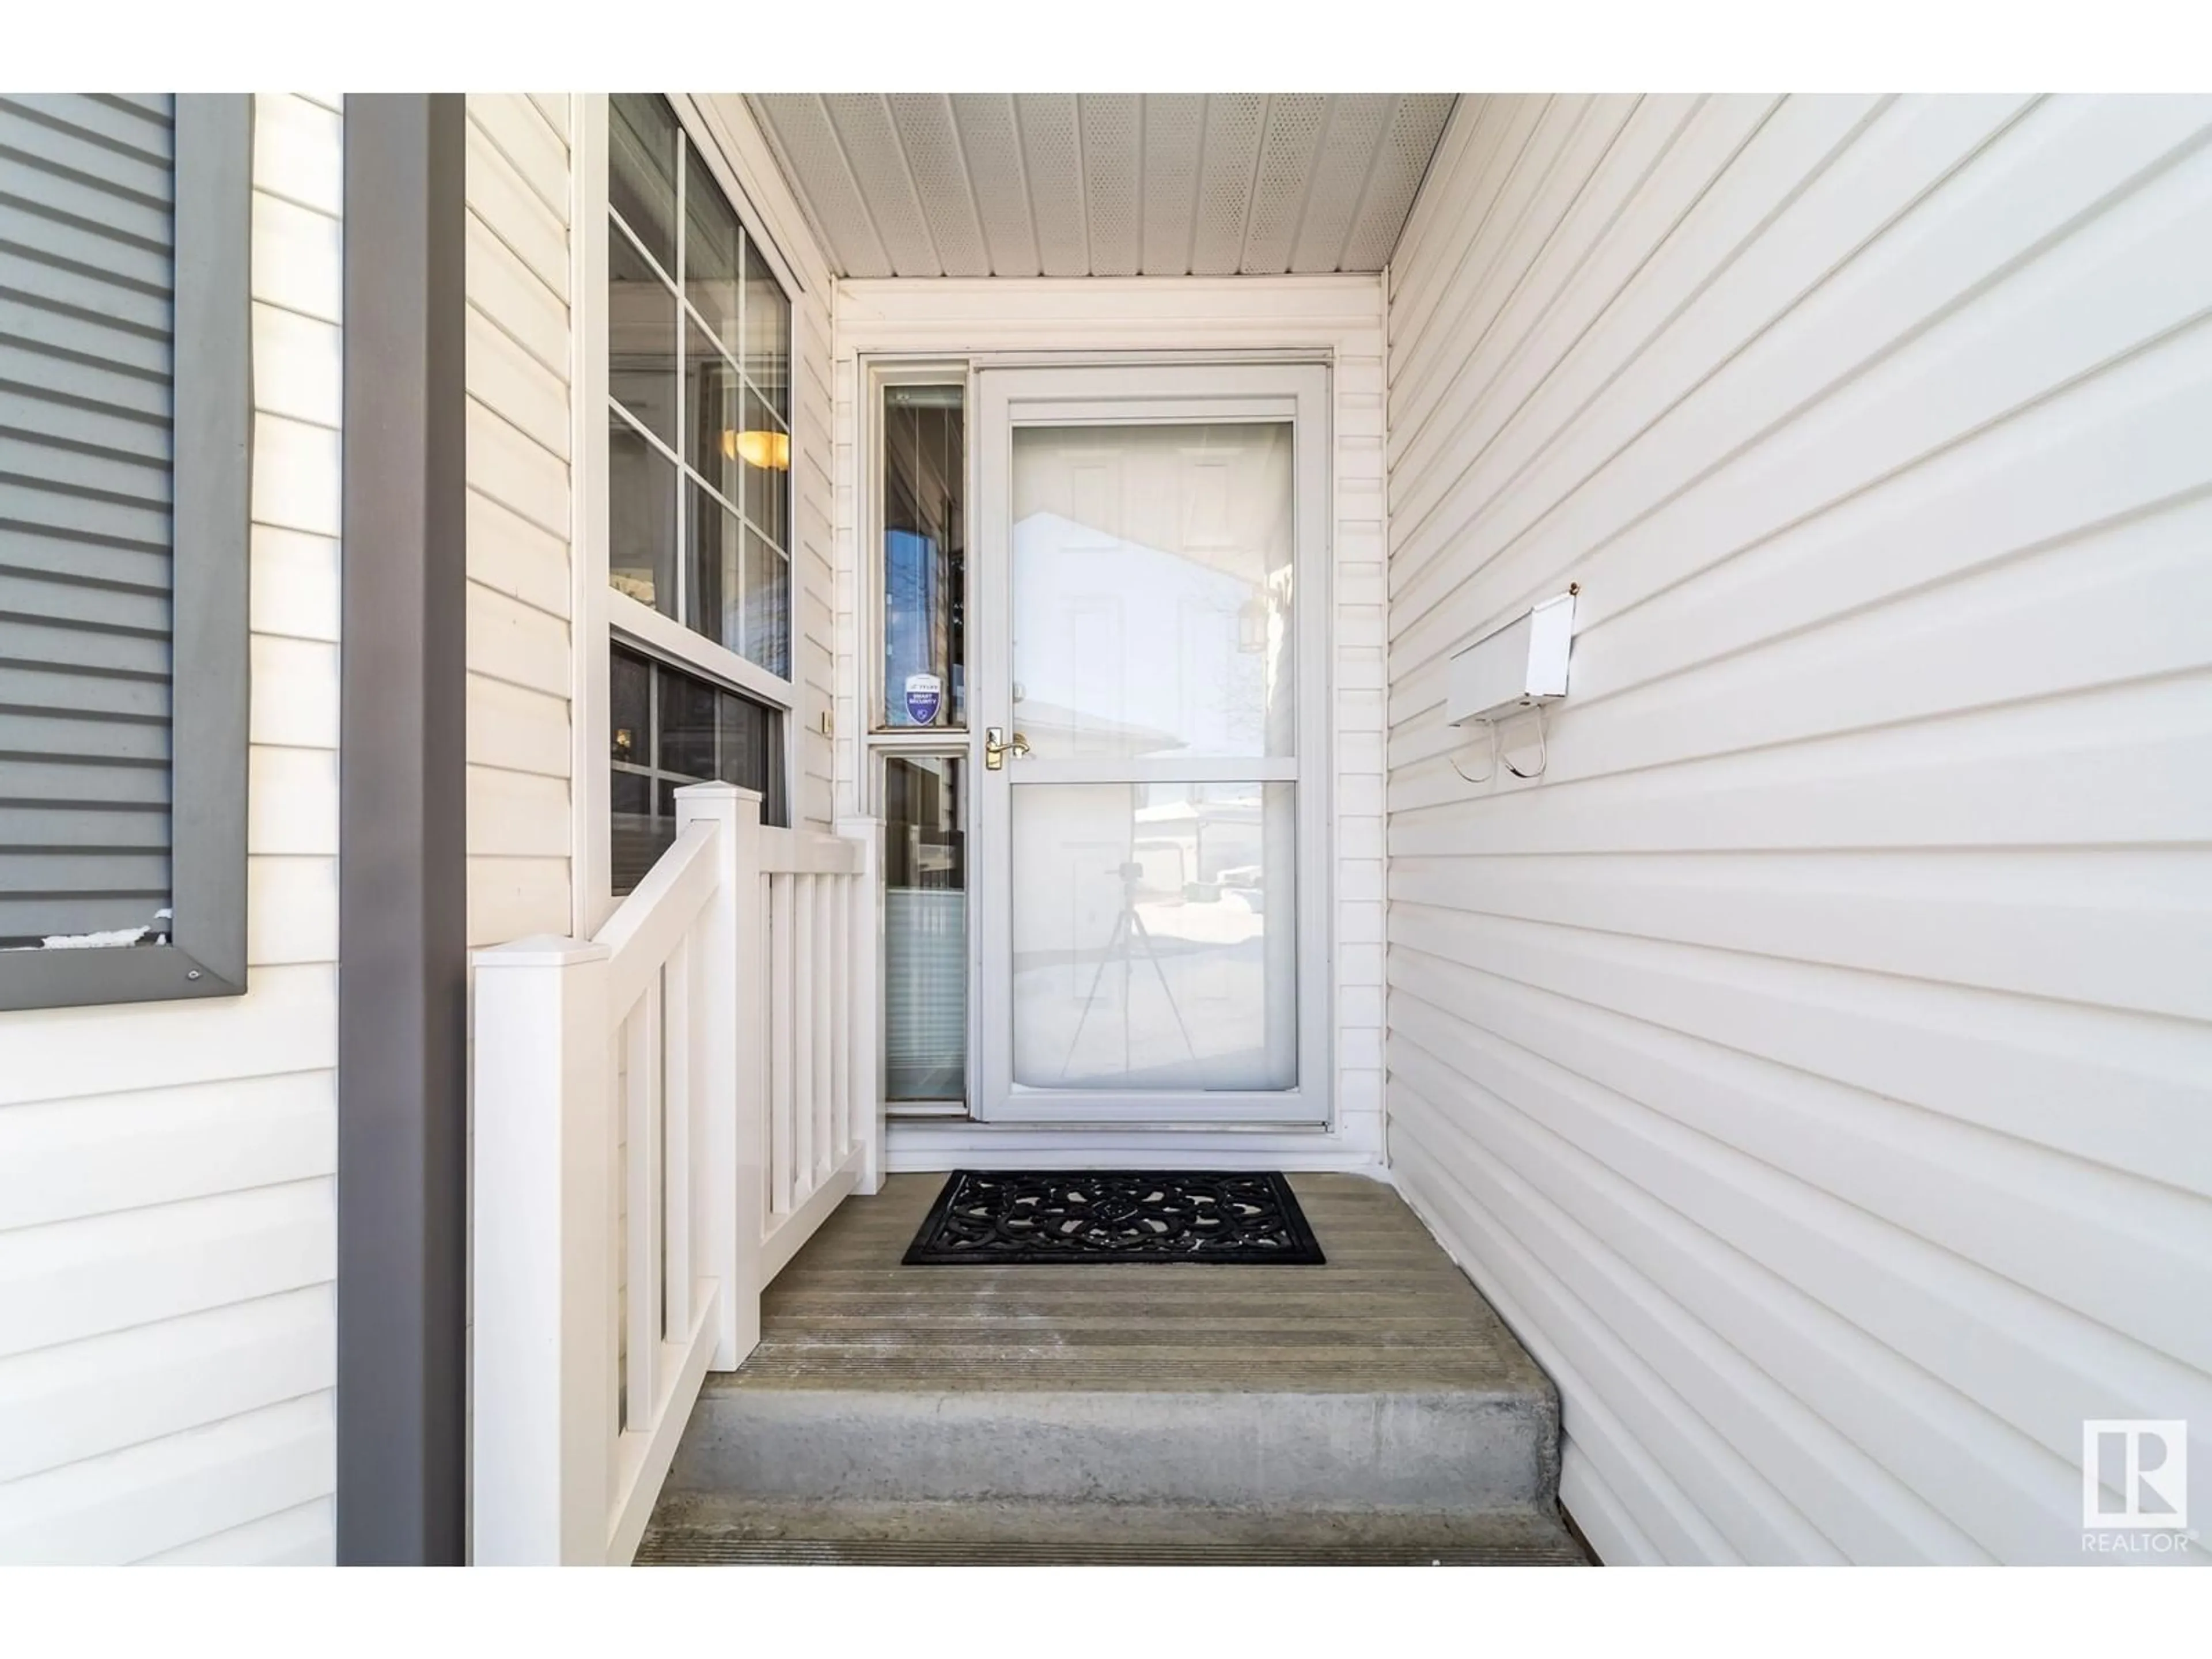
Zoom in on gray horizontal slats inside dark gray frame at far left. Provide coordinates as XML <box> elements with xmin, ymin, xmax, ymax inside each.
<box><xmin>0</xmin><ymin>95</ymin><xmax>175</xmax><ymax>947</ymax></box>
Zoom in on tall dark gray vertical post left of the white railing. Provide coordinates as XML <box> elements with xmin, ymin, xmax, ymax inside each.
<box><xmin>336</xmin><ymin>93</ymin><xmax>469</xmax><ymax>1564</ymax></box>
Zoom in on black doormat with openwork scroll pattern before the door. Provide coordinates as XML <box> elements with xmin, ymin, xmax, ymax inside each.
<box><xmin>905</xmin><ymin>1170</ymin><xmax>1327</xmax><ymax>1267</ymax></box>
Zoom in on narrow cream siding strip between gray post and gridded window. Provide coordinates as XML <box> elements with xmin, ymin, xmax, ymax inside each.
<box><xmin>467</xmin><ymin>93</ymin><xmax>575</xmax><ymax>947</ymax></box>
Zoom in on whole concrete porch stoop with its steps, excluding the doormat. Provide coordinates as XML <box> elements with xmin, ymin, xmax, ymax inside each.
<box><xmin>648</xmin><ymin>1177</ymin><xmax>1559</xmax><ymax>1562</ymax></box>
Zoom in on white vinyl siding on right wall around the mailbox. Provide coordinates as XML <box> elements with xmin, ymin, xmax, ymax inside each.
<box><xmin>1387</xmin><ymin>97</ymin><xmax>2212</xmax><ymax>1562</ymax></box>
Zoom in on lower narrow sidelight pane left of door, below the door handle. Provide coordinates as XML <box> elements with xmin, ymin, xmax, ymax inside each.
<box><xmin>882</xmin><ymin>754</ymin><xmax>969</xmax><ymax>1104</ymax></box>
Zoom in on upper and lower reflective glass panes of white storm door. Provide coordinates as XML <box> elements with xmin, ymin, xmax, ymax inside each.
<box><xmin>1011</xmin><ymin>422</ymin><xmax>1298</xmax><ymax>1106</ymax></box>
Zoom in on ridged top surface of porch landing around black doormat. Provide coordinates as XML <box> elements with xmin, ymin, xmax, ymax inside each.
<box><xmin>708</xmin><ymin>1175</ymin><xmax>1548</xmax><ymax>1393</ymax></box>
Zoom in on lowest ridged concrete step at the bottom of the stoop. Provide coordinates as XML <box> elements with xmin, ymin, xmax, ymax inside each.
<box><xmin>637</xmin><ymin>1495</ymin><xmax>1588</xmax><ymax>1566</ymax></box>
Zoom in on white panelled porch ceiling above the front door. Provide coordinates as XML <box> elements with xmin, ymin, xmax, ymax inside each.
<box><xmin>748</xmin><ymin>93</ymin><xmax>1453</xmax><ymax>276</ymax></box>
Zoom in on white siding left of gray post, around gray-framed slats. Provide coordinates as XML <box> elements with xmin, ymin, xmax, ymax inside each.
<box><xmin>0</xmin><ymin>95</ymin><xmax>343</xmax><ymax>1562</ymax></box>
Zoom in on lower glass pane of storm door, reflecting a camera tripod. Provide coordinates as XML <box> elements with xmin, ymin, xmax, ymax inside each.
<box><xmin>1011</xmin><ymin>783</ymin><xmax>1298</xmax><ymax>1090</ymax></box>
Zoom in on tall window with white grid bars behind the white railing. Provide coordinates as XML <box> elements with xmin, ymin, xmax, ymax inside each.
<box><xmin>606</xmin><ymin>93</ymin><xmax>792</xmax><ymax>892</ymax></box>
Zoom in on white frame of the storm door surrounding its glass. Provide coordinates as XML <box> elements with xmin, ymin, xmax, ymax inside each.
<box><xmin>969</xmin><ymin>363</ymin><xmax>1334</xmax><ymax>1128</ymax></box>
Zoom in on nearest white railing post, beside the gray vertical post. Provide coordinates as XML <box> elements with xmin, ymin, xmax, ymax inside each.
<box><xmin>469</xmin><ymin>938</ymin><xmax>615</xmax><ymax>1566</ymax></box>
